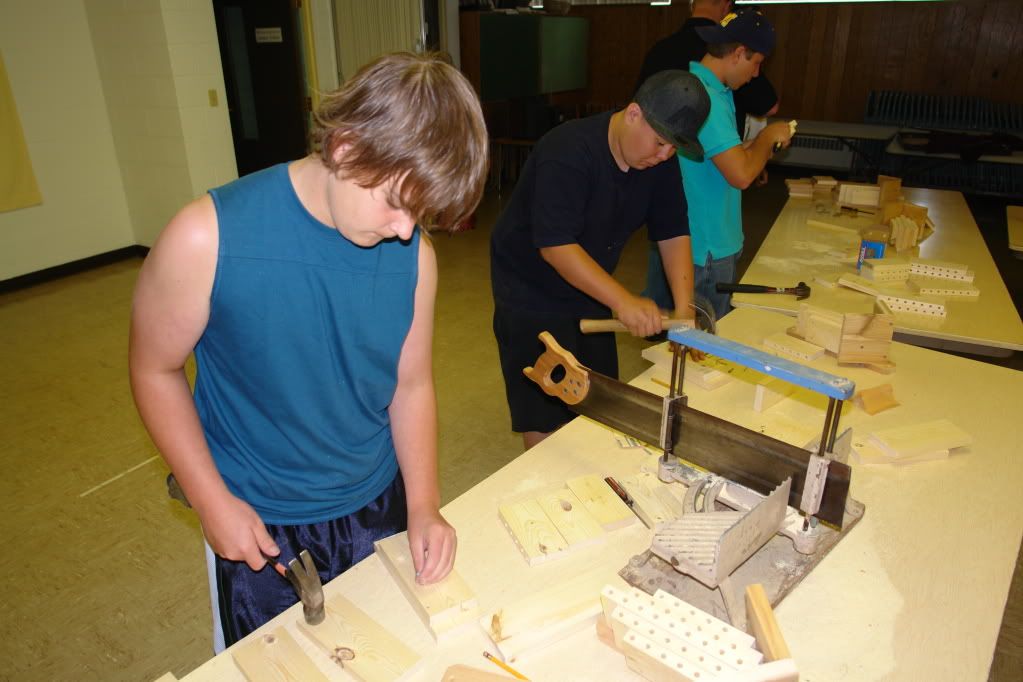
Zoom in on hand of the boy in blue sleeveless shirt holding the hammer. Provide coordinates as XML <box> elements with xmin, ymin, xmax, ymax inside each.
<box><xmin>199</xmin><ymin>495</ymin><xmax>280</xmax><ymax>571</ymax></box>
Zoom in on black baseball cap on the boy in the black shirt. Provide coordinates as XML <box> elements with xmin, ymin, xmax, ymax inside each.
<box><xmin>633</xmin><ymin>70</ymin><xmax>710</xmax><ymax>161</ymax></box>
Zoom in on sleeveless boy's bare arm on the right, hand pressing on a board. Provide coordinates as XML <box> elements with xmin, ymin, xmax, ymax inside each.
<box><xmin>389</xmin><ymin>233</ymin><xmax>456</xmax><ymax>585</ymax></box>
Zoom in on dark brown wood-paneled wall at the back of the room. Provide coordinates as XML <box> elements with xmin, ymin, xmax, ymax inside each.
<box><xmin>527</xmin><ymin>0</ymin><xmax>1023</xmax><ymax>122</ymax></box>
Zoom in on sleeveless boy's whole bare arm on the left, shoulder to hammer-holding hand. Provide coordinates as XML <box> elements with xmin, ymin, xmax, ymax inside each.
<box><xmin>128</xmin><ymin>196</ymin><xmax>280</xmax><ymax>571</ymax></box>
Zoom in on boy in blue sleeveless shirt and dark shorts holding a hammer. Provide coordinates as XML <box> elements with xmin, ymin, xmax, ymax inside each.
<box><xmin>130</xmin><ymin>54</ymin><xmax>487</xmax><ymax>649</ymax></box>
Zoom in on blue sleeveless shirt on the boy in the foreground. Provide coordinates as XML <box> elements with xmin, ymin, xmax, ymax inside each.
<box><xmin>194</xmin><ymin>164</ymin><xmax>419</xmax><ymax>525</ymax></box>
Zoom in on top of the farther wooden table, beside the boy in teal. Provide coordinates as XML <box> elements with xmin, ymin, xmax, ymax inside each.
<box><xmin>732</xmin><ymin>188</ymin><xmax>1023</xmax><ymax>357</ymax></box>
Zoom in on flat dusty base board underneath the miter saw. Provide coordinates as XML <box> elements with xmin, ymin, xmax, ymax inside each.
<box><xmin>618</xmin><ymin>497</ymin><xmax>864</xmax><ymax>630</ymax></box>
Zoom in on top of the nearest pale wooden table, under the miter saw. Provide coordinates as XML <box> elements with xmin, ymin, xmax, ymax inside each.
<box><xmin>175</xmin><ymin>310</ymin><xmax>1023</xmax><ymax>682</ymax></box>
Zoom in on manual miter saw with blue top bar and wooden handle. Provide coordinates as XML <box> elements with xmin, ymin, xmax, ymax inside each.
<box><xmin>524</xmin><ymin>328</ymin><xmax>863</xmax><ymax>627</ymax></box>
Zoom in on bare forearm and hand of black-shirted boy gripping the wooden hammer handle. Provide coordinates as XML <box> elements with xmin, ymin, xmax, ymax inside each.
<box><xmin>540</xmin><ymin>243</ymin><xmax>661</xmax><ymax>336</ymax></box>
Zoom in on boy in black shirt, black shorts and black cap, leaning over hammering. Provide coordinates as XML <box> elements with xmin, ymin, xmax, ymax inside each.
<box><xmin>490</xmin><ymin>71</ymin><xmax>710</xmax><ymax>448</ymax></box>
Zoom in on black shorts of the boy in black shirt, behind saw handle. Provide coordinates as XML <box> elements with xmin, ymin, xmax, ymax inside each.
<box><xmin>494</xmin><ymin>305</ymin><xmax>618</xmax><ymax>434</ymax></box>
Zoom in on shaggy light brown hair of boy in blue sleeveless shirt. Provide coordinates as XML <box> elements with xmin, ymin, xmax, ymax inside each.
<box><xmin>312</xmin><ymin>52</ymin><xmax>489</xmax><ymax>229</ymax></box>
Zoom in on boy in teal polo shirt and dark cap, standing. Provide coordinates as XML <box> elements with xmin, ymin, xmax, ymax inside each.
<box><xmin>678</xmin><ymin>11</ymin><xmax>792</xmax><ymax>318</ymax></box>
